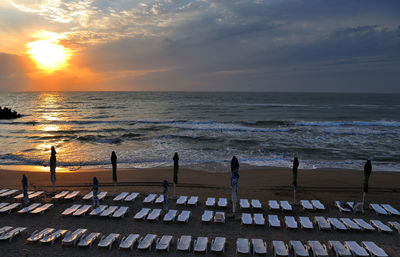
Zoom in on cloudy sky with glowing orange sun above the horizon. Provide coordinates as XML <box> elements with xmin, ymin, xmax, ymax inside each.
<box><xmin>0</xmin><ymin>0</ymin><xmax>400</xmax><ymax>93</ymax></box>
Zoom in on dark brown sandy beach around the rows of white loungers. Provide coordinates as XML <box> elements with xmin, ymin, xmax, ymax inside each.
<box><xmin>0</xmin><ymin>168</ymin><xmax>400</xmax><ymax>256</ymax></box>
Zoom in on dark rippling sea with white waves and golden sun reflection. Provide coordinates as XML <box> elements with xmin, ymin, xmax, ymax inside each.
<box><xmin>0</xmin><ymin>92</ymin><xmax>400</xmax><ymax>172</ymax></box>
